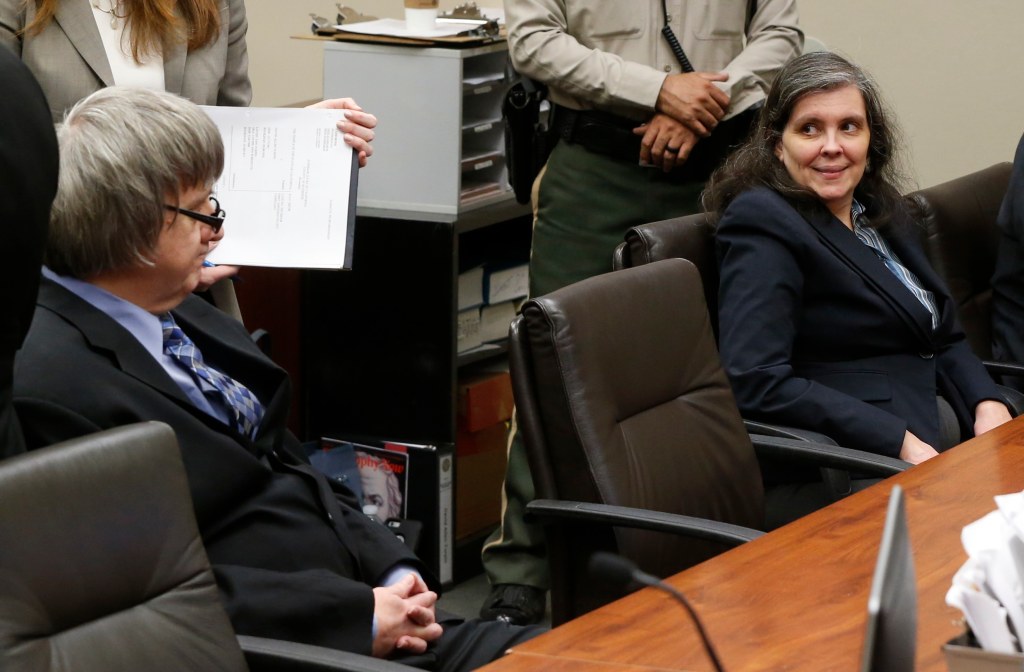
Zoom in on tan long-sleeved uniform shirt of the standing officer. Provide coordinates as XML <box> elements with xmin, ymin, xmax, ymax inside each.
<box><xmin>505</xmin><ymin>0</ymin><xmax>804</xmax><ymax>120</ymax></box>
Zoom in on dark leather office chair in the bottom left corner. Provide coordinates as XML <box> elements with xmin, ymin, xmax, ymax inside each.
<box><xmin>0</xmin><ymin>422</ymin><xmax>410</xmax><ymax>672</ymax></box>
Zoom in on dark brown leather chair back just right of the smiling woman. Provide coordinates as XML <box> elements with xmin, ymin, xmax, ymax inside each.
<box><xmin>909</xmin><ymin>162</ymin><xmax>1013</xmax><ymax>360</ymax></box>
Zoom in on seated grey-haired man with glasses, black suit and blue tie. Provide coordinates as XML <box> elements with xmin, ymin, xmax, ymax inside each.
<box><xmin>12</xmin><ymin>87</ymin><xmax>534</xmax><ymax>671</ymax></box>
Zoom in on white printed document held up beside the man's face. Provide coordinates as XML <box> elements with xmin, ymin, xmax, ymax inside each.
<box><xmin>203</xmin><ymin>106</ymin><xmax>358</xmax><ymax>268</ymax></box>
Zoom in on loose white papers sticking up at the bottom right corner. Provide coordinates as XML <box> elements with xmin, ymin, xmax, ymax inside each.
<box><xmin>946</xmin><ymin>493</ymin><xmax>1024</xmax><ymax>654</ymax></box>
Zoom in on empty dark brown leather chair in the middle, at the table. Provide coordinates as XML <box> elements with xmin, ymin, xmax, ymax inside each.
<box><xmin>509</xmin><ymin>259</ymin><xmax>905</xmax><ymax>623</ymax></box>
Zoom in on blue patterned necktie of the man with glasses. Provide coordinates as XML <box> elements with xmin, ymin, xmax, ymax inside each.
<box><xmin>160</xmin><ymin>312</ymin><xmax>263</xmax><ymax>436</ymax></box>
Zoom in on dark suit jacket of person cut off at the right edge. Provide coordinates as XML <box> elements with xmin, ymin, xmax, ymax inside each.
<box><xmin>992</xmin><ymin>131</ymin><xmax>1024</xmax><ymax>376</ymax></box>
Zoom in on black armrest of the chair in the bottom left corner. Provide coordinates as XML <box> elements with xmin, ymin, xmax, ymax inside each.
<box><xmin>238</xmin><ymin>635</ymin><xmax>413</xmax><ymax>672</ymax></box>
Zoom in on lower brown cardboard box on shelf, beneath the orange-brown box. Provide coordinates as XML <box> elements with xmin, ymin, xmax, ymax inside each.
<box><xmin>455</xmin><ymin>422</ymin><xmax>509</xmax><ymax>540</ymax></box>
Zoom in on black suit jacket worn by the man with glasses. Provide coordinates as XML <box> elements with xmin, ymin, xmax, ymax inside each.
<box><xmin>14</xmin><ymin>280</ymin><xmax>436</xmax><ymax>654</ymax></box>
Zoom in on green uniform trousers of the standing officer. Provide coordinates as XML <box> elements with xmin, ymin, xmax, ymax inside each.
<box><xmin>482</xmin><ymin>142</ymin><xmax>703</xmax><ymax>590</ymax></box>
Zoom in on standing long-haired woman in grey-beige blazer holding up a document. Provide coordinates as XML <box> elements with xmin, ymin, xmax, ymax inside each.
<box><xmin>0</xmin><ymin>0</ymin><xmax>377</xmax><ymax>290</ymax></box>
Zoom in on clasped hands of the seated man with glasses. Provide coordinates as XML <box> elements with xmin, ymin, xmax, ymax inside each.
<box><xmin>373</xmin><ymin>574</ymin><xmax>441</xmax><ymax>658</ymax></box>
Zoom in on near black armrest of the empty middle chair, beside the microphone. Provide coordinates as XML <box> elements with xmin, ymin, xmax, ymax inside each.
<box><xmin>526</xmin><ymin>499</ymin><xmax>764</xmax><ymax>546</ymax></box>
